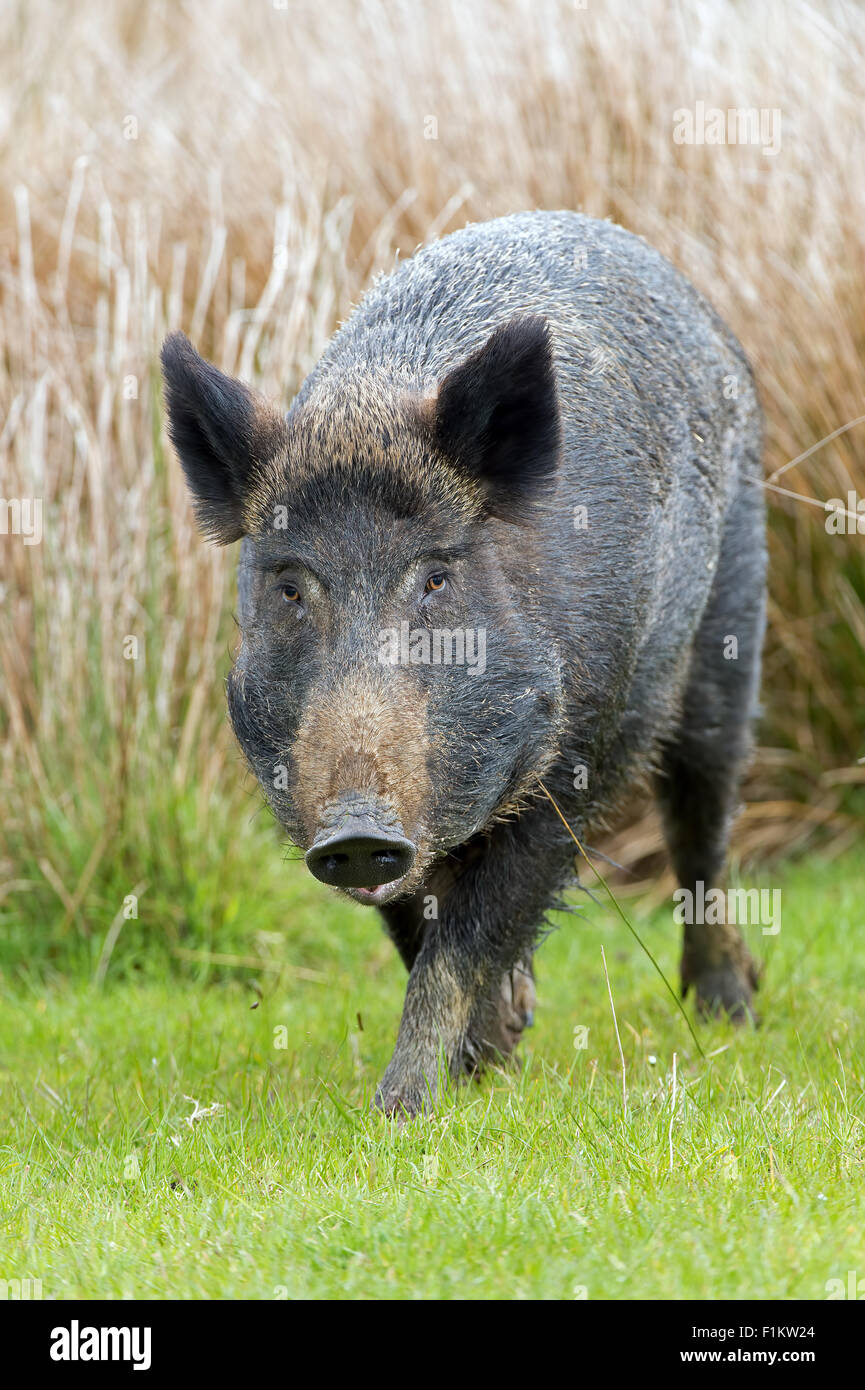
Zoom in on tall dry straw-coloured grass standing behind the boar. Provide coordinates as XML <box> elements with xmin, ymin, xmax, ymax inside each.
<box><xmin>0</xmin><ymin>0</ymin><xmax>865</xmax><ymax>930</ymax></box>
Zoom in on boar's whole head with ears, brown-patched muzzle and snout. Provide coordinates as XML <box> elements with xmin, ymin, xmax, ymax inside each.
<box><xmin>163</xmin><ymin>317</ymin><xmax>562</xmax><ymax>905</ymax></box>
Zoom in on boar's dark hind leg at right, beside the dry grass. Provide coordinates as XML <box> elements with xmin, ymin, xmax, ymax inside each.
<box><xmin>656</xmin><ymin>487</ymin><xmax>765</xmax><ymax>1022</ymax></box>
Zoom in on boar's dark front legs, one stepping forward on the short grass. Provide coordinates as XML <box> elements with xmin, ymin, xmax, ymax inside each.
<box><xmin>375</xmin><ymin>810</ymin><xmax>570</xmax><ymax>1115</ymax></box>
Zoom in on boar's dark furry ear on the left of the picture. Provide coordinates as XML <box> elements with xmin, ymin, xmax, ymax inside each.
<box><xmin>163</xmin><ymin>334</ymin><xmax>282</xmax><ymax>545</ymax></box>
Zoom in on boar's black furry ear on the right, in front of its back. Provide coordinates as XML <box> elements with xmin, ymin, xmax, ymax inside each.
<box><xmin>434</xmin><ymin>316</ymin><xmax>562</xmax><ymax>516</ymax></box>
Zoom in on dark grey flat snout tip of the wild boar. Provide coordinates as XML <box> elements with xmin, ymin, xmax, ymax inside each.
<box><xmin>306</xmin><ymin>803</ymin><xmax>417</xmax><ymax>888</ymax></box>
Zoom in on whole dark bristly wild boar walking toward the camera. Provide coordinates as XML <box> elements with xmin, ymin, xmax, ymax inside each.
<box><xmin>163</xmin><ymin>211</ymin><xmax>766</xmax><ymax>1115</ymax></box>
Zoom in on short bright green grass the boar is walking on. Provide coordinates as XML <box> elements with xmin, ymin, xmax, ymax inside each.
<box><xmin>0</xmin><ymin>834</ymin><xmax>865</xmax><ymax>1298</ymax></box>
